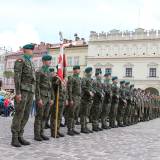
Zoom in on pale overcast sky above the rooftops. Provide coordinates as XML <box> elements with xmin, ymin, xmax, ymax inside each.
<box><xmin>0</xmin><ymin>0</ymin><xmax>160</xmax><ymax>50</ymax></box>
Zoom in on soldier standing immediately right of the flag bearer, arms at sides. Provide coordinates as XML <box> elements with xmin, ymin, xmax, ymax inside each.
<box><xmin>67</xmin><ymin>65</ymin><xmax>81</xmax><ymax>136</ymax></box>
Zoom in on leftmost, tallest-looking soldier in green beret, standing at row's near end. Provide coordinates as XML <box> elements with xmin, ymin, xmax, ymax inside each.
<box><xmin>11</xmin><ymin>44</ymin><xmax>36</xmax><ymax>147</ymax></box>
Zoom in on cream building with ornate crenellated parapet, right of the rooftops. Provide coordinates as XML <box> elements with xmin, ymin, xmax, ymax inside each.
<box><xmin>87</xmin><ymin>28</ymin><xmax>160</xmax><ymax>92</ymax></box>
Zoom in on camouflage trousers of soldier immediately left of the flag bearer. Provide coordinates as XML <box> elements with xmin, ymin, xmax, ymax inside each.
<box><xmin>34</xmin><ymin>97</ymin><xmax>50</xmax><ymax>137</ymax></box>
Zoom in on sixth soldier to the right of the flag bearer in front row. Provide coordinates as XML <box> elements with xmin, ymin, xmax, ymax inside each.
<box><xmin>117</xmin><ymin>81</ymin><xmax>127</xmax><ymax>127</ymax></box>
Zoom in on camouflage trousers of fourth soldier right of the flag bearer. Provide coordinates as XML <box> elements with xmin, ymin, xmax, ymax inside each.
<box><xmin>101</xmin><ymin>101</ymin><xmax>111</xmax><ymax>127</ymax></box>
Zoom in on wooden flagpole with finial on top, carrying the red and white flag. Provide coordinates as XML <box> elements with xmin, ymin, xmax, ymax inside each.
<box><xmin>54</xmin><ymin>32</ymin><xmax>63</xmax><ymax>138</ymax></box>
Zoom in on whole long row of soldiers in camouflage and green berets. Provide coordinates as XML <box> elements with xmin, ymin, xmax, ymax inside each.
<box><xmin>11</xmin><ymin>44</ymin><xmax>160</xmax><ymax>147</ymax></box>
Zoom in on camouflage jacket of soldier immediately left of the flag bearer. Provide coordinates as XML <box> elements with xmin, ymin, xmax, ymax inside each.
<box><xmin>36</xmin><ymin>67</ymin><xmax>54</xmax><ymax>100</ymax></box>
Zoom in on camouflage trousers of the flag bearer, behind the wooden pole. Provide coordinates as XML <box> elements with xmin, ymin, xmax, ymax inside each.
<box><xmin>50</xmin><ymin>99</ymin><xmax>65</xmax><ymax>136</ymax></box>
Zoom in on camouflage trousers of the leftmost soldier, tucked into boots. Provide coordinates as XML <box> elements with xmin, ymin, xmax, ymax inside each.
<box><xmin>11</xmin><ymin>91</ymin><xmax>34</xmax><ymax>137</ymax></box>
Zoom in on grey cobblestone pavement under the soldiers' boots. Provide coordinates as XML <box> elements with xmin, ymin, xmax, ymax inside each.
<box><xmin>0</xmin><ymin>117</ymin><xmax>160</xmax><ymax>160</ymax></box>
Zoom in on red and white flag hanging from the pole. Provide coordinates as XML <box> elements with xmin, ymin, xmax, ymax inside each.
<box><xmin>57</xmin><ymin>44</ymin><xmax>67</xmax><ymax>80</ymax></box>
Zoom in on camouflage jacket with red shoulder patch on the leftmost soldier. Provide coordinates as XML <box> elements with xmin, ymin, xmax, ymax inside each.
<box><xmin>14</xmin><ymin>56</ymin><xmax>36</xmax><ymax>95</ymax></box>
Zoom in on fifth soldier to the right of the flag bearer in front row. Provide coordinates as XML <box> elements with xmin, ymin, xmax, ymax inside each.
<box><xmin>110</xmin><ymin>77</ymin><xmax>119</xmax><ymax>128</ymax></box>
